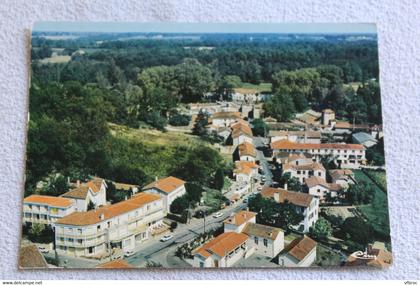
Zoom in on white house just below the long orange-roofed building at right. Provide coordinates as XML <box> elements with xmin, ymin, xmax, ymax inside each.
<box><xmin>282</xmin><ymin>162</ymin><xmax>325</xmax><ymax>183</ymax></box>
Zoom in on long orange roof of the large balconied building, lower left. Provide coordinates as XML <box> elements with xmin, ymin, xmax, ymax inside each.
<box><xmin>56</xmin><ymin>193</ymin><xmax>161</xmax><ymax>226</ymax></box>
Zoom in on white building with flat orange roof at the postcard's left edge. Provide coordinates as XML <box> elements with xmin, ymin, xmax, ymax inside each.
<box><xmin>23</xmin><ymin>195</ymin><xmax>76</xmax><ymax>225</ymax></box>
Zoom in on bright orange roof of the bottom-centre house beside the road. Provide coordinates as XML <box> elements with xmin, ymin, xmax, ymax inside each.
<box><xmin>194</xmin><ymin>232</ymin><xmax>248</xmax><ymax>258</ymax></box>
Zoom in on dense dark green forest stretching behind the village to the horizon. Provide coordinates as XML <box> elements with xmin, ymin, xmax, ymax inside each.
<box><xmin>26</xmin><ymin>32</ymin><xmax>381</xmax><ymax>194</ymax></box>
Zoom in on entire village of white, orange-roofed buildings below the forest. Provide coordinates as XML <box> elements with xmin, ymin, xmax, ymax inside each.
<box><xmin>21</xmin><ymin>88</ymin><xmax>392</xmax><ymax>268</ymax></box>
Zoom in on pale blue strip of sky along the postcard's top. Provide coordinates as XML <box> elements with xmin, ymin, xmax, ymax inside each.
<box><xmin>33</xmin><ymin>22</ymin><xmax>376</xmax><ymax>34</ymax></box>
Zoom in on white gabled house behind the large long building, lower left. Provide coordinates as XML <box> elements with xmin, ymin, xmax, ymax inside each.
<box><xmin>61</xmin><ymin>177</ymin><xmax>107</xmax><ymax>212</ymax></box>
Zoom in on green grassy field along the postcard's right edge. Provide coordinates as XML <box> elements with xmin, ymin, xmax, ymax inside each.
<box><xmin>354</xmin><ymin>170</ymin><xmax>389</xmax><ymax>240</ymax></box>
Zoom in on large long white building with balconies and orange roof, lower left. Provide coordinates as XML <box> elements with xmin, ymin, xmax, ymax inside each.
<box><xmin>54</xmin><ymin>193</ymin><xmax>165</xmax><ymax>257</ymax></box>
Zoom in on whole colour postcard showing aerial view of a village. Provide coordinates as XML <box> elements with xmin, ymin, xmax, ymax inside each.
<box><xmin>19</xmin><ymin>22</ymin><xmax>392</xmax><ymax>269</ymax></box>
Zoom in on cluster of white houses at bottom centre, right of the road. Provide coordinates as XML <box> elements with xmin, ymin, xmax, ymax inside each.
<box><xmin>192</xmin><ymin>211</ymin><xmax>317</xmax><ymax>268</ymax></box>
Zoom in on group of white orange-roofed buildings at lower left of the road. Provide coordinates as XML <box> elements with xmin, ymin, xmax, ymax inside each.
<box><xmin>23</xmin><ymin>177</ymin><xmax>186</xmax><ymax>258</ymax></box>
